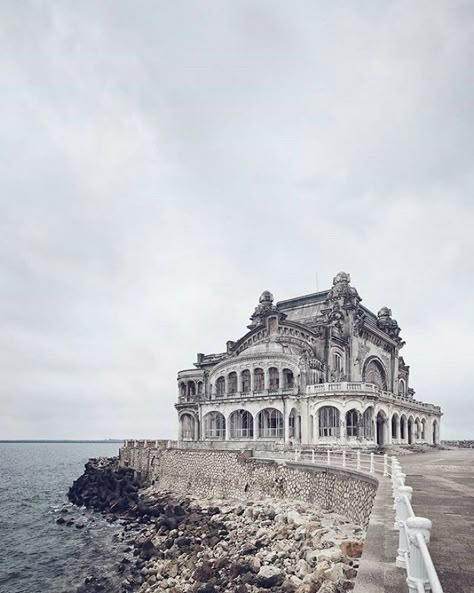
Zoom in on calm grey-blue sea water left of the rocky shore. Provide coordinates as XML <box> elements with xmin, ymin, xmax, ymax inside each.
<box><xmin>0</xmin><ymin>443</ymin><xmax>124</xmax><ymax>593</ymax></box>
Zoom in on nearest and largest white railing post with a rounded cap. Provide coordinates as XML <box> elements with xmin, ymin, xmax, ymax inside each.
<box><xmin>406</xmin><ymin>517</ymin><xmax>431</xmax><ymax>593</ymax></box>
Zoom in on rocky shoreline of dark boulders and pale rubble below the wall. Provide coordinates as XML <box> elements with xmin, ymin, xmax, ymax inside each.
<box><xmin>65</xmin><ymin>459</ymin><xmax>365</xmax><ymax>593</ymax></box>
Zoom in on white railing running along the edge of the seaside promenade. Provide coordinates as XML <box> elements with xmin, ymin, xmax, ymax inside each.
<box><xmin>286</xmin><ymin>449</ymin><xmax>443</xmax><ymax>593</ymax></box>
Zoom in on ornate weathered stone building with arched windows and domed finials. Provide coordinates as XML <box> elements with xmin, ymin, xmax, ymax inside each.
<box><xmin>176</xmin><ymin>272</ymin><xmax>442</xmax><ymax>448</ymax></box>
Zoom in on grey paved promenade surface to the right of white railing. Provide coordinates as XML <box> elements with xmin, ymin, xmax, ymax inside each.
<box><xmin>399</xmin><ymin>449</ymin><xmax>474</xmax><ymax>593</ymax></box>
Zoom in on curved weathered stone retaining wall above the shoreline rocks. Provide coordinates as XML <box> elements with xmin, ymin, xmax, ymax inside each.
<box><xmin>120</xmin><ymin>448</ymin><xmax>378</xmax><ymax>526</ymax></box>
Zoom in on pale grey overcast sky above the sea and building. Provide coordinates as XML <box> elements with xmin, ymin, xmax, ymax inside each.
<box><xmin>0</xmin><ymin>0</ymin><xmax>474</xmax><ymax>438</ymax></box>
